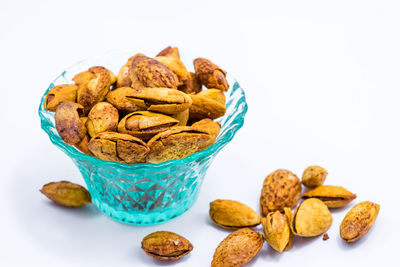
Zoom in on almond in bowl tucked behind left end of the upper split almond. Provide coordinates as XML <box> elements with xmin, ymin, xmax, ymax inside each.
<box><xmin>107</xmin><ymin>87</ymin><xmax>145</xmax><ymax>114</ymax></box>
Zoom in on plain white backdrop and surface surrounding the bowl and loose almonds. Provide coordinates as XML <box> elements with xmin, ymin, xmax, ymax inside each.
<box><xmin>0</xmin><ymin>0</ymin><xmax>400</xmax><ymax>267</ymax></box>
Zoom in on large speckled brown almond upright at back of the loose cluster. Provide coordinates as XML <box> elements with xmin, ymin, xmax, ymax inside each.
<box><xmin>260</xmin><ymin>170</ymin><xmax>301</xmax><ymax>217</ymax></box>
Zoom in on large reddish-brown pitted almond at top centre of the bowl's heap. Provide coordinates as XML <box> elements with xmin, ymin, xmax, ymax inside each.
<box><xmin>129</xmin><ymin>56</ymin><xmax>179</xmax><ymax>89</ymax></box>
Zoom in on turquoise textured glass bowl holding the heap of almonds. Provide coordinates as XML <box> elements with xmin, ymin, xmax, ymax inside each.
<box><xmin>39</xmin><ymin>51</ymin><xmax>247</xmax><ymax>225</ymax></box>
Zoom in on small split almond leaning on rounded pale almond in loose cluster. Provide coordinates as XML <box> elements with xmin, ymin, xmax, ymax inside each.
<box><xmin>261</xmin><ymin>211</ymin><xmax>293</xmax><ymax>252</ymax></box>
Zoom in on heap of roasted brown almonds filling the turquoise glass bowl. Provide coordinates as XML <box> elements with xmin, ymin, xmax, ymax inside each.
<box><xmin>44</xmin><ymin>47</ymin><xmax>229</xmax><ymax>164</ymax></box>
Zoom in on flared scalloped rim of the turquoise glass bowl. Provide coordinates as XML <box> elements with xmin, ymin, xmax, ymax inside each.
<box><xmin>38</xmin><ymin>49</ymin><xmax>248</xmax><ymax>169</ymax></box>
